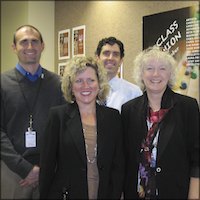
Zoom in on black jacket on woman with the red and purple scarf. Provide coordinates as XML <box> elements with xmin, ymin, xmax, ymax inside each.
<box><xmin>122</xmin><ymin>88</ymin><xmax>199</xmax><ymax>199</ymax></box>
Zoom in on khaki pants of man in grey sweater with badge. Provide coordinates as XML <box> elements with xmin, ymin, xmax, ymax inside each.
<box><xmin>1</xmin><ymin>161</ymin><xmax>39</xmax><ymax>199</ymax></box>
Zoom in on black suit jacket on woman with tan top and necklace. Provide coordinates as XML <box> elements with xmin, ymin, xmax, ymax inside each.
<box><xmin>39</xmin><ymin>103</ymin><xmax>124</xmax><ymax>199</ymax></box>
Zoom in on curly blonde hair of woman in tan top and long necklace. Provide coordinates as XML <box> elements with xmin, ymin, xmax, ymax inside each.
<box><xmin>61</xmin><ymin>56</ymin><xmax>110</xmax><ymax>103</ymax></box>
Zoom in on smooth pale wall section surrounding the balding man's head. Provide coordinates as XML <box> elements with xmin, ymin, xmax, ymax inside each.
<box><xmin>1</xmin><ymin>1</ymin><xmax>55</xmax><ymax>72</ymax></box>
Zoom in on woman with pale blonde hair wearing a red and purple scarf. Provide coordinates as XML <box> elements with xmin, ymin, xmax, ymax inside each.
<box><xmin>122</xmin><ymin>47</ymin><xmax>199</xmax><ymax>199</ymax></box>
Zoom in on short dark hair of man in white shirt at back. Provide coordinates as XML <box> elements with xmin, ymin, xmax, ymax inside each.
<box><xmin>95</xmin><ymin>37</ymin><xmax>124</xmax><ymax>58</ymax></box>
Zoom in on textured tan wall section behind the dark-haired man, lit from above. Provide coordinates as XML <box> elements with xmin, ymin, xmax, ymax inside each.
<box><xmin>55</xmin><ymin>1</ymin><xmax>198</xmax><ymax>82</ymax></box>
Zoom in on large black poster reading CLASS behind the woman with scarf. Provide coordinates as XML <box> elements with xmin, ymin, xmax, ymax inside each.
<box><xmin>143</xmin><ymin>6</ymin><xmax>200</xmax><ymax>102</ymax></box>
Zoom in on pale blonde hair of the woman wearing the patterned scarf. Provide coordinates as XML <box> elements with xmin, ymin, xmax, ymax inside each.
<box><xmin>133</xmin><ymin>46</ymin><xmax>177</xmax><ymax>91</ymax></box>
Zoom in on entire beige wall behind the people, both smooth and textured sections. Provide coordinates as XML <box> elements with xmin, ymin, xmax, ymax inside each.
<box><xmin>1</xmin><ymin>1</ymin><xmax>198</xmax><ymax>81</ymax></box>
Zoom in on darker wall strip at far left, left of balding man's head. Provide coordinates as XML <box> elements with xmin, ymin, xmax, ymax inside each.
<box><xmin>1</xmin><ymin>1</ymin><xmax>28</xmax><ymax>72</ymax></box>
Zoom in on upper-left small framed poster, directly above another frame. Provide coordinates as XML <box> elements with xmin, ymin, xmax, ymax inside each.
<box><xmin>58</xmin><ymin>29</ymin><xmax>70</xmax><ymax>60</ymax></box>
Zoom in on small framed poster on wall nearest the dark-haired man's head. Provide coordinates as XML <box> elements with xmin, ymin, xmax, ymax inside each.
<box><xmin>72</xmin><ymin>25</ymin><xmax>85</xmax><ymax>57</ymax></box>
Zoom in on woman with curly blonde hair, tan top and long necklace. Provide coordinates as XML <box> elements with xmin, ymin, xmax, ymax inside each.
<box><xmin>40</xmin><ymin>57</ymin><xmax>124</xmax><ymax>199</ymax></box>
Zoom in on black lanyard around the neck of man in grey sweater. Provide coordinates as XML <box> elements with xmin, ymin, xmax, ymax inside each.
<box><xmin>15</xmin><ymin>71</ymin><xmax>42</xmax><ymax>130</ymax></box>
